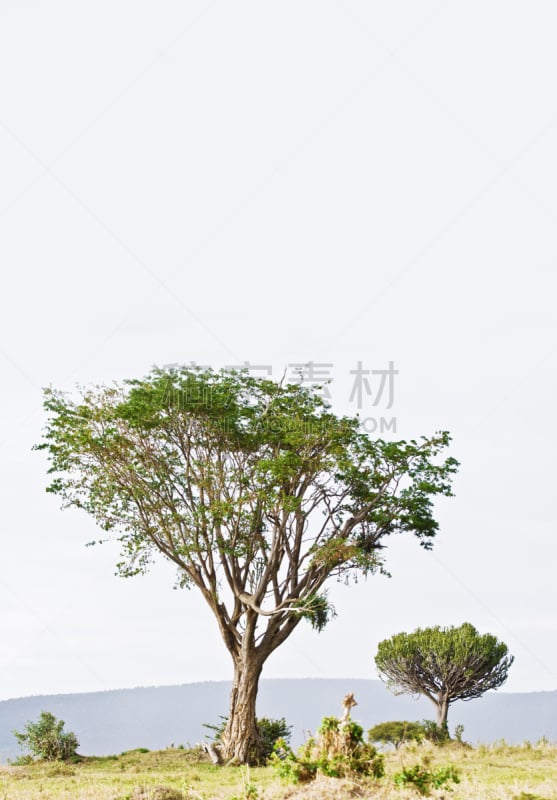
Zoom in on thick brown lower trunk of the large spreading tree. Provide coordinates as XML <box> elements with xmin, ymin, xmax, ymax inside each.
<box><xmin>222</xmin><ymin>649</ymin><xmax>264</xmax><ymax>764</ymax></box>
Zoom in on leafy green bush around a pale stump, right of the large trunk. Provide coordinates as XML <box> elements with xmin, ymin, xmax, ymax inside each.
<box><xmin>271</xmin><ymin>717</ymin><xmax>384</xmax><ymax>783</ymax></box>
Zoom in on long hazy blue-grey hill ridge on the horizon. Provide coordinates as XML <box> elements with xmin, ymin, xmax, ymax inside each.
<box><xmin>0</xmin><ymin>678</ymin><xmax>557</xmax><ymax>763</ymax></box>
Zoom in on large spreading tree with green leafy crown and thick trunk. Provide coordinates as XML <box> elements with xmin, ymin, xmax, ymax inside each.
<box><xmin>38</xmin><ymin>369</ymin><xmax>457</xmax><ymax>762</ymax></box>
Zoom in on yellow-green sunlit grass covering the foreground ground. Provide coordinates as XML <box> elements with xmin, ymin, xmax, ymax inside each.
<box><xmin>0</xmin><ymin>742</ymin><xmax>557</xmax><ymax>800</ymax></box>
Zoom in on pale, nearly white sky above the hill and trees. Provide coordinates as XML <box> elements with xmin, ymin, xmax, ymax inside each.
<box><xmin>0</xmin><ymin>0</ymin><xmax>557</xmax><ymax>699</ymax></box>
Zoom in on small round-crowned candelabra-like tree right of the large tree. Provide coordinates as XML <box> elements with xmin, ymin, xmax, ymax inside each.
<box><xmin>375</xmin><ymin>622</ymin><xmax>514</xmax><ymax>729</ymax></box>
